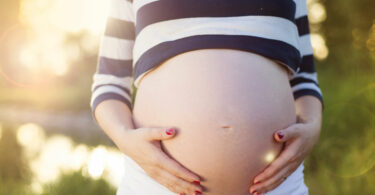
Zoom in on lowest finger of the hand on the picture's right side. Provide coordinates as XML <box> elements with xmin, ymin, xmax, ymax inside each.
<box><xmin>249</xmin><ymin>163</ymin><xmax>298</xmax><ymax>193</ymax></box>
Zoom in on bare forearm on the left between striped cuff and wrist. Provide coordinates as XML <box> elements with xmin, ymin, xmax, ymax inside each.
<box><xmin>95</xmin><ymin>100</ymin><xmax>134</xmax><ymax>147</ymax></box>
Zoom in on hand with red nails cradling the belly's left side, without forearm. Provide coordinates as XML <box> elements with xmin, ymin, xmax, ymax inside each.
<box><xmin>119</xmin><ymin>128</ymin><xmax>203</xmax><ymax>195</ymax></box>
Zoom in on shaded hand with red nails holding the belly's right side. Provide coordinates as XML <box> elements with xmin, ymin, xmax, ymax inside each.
<box><xmin>249</xmin><ymin>109</ymin><xmax>321</xmax><ymax>195</ymax></box>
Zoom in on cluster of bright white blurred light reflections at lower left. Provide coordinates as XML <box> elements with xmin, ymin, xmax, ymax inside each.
<box><xmin>12</xmin><ymin>123</ymin><xmax>124</xmax><ymax>193</ymax></box>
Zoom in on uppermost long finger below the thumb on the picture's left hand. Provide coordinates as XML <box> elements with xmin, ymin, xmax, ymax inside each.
<box><xmin>158</xmin><ymin>152</ymin><xmax>200</xmax><ymax>182</ymax></box>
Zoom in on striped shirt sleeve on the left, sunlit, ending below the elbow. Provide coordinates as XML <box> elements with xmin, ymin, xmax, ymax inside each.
<box><xmin>90</xmin><ymin>0</ymin><xmax>135</xmax><ymax>125</ymax></box>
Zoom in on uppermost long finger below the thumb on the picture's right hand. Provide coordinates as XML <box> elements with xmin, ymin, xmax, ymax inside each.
<box><xmin>254</xmin><ymin>144</ymin><xmax>298</xmax><ymax>183</ymax></box>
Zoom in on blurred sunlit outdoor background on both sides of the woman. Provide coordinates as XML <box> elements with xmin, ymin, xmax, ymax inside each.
<box><xmin>0</xmin><ymin>0</ymin><xmax>375</xmax><ymax>195</ymax></box>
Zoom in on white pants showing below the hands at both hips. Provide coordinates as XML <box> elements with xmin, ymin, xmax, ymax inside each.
<box><xmin>116</xmin><ymin>155</ymin><xmax>308</xmax><ymax>195</ymax></box>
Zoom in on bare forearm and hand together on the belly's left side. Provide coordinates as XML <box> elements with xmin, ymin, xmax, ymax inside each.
<box><xmin>95</xmin><ymin>100</ymin><xmax>203</xmax><ymax>195</ymax></box>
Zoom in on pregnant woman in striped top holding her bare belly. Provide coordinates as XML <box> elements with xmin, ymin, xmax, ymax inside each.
<box><xmin>91</xmin><ymin>0</ymin><xmax>323</xmax><ymax>195</ymax></box>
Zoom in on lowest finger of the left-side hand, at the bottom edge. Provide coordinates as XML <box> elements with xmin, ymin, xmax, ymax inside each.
<box><xmin>158</xmin><ymin>169</ymin><xmax>203</xmax><ymax>194</ymax></box>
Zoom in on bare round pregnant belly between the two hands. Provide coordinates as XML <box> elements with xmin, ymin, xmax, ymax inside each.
<box><xmin>133</xmin><ymin>49</ymin><xmax>296</xmax><ymax>195</ymax></box>
